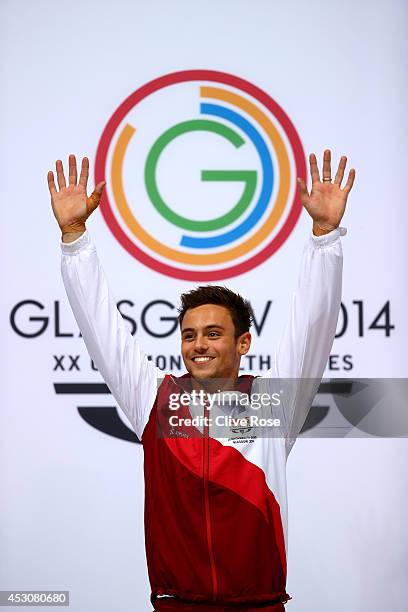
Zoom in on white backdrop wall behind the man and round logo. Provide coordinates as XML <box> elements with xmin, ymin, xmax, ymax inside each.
<box><xmin>0</xmin><ymin>0</ymin><xmax>408</xmax><ymax>612</ymax></box>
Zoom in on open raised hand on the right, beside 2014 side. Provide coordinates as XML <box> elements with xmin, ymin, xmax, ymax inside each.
<box><xmin>298</xmin><ymin>149</ymin><xmax>355</xmax><ymax>232</ymax></box>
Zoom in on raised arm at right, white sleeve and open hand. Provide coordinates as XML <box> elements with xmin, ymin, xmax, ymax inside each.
<box><xmin>270</xmin><ymin>150</ymin><xmax>355</xmax><ymax>453</ymax></box>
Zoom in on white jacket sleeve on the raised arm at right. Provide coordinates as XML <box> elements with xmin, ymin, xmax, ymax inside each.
<box><xmin>268</xmin><ymin>227</ymin><xmax>347</xmax><ymax>454</ymax></box>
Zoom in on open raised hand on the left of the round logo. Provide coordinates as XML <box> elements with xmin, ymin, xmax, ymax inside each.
<box><xmin>47</xmin><ymin>155</ymin><xmax>106</xmax><ymax>242</ymax></box>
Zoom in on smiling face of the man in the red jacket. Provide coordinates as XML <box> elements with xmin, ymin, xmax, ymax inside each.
<box><xmin>181</xmin><ymin>304</ymin><xmax>251</xmax><ymax>380</ymax></box>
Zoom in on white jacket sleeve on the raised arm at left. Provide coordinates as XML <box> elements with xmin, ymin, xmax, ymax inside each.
<box><xmin>60</xmin><ymin>231</ymin><xmax>163</xmax><ymax>439</ymax></box>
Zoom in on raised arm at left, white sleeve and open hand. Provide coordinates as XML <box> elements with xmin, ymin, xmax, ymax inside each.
<box><xmin>48</xmin><ymin>155</ymin><xmax>160</xmax><ymax>438</ymax></box>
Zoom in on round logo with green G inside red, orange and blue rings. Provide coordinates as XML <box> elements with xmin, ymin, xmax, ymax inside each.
<box><xmin>95</xmin><ymin>70</ymin><xmax>306</xmax><ymax>281</ymax></box>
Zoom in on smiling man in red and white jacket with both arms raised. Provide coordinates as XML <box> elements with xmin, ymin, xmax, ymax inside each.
<box><xmin>48</xmin><ymin>150</ymin><xmax>355</xmax><ymax>612</ymax></box>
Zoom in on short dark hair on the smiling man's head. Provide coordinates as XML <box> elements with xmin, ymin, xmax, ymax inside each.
<box><xmin>178</xmin><ymin>285</ymin><xmax>254</xmax><ymax>338</ymax></box>
